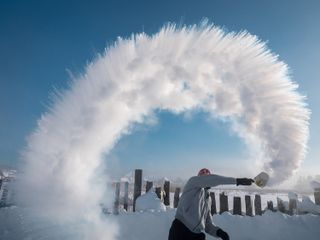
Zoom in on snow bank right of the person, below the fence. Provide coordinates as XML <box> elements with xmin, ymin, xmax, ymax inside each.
<box><xmin>214</xmin><ymin>211</ymin><xmax>320</xmax><ymax>240</ymax></box>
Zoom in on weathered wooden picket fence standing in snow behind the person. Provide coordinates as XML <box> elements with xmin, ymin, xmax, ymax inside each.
<box><xmin>113</xmin><ymin>169</ymin><xmax>320</xmax><ymax>216</ymax></box>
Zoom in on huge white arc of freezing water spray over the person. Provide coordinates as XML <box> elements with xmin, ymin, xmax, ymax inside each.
<box><xmin>23</xmin><ymin>24</ymin><xmax>309</xmax><ymax>239</ymax></box>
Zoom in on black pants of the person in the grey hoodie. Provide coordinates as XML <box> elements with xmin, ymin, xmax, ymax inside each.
<box><xmin>169</xmin><ymin>219</ymin><xmax>206</xmax><ymax>240</ymax></box>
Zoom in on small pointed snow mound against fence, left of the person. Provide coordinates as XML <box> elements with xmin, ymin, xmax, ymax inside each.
<box><xmin>136</xmin><ymin>188</ymin><xmax>166</xmax><ymax>212</ymax></box>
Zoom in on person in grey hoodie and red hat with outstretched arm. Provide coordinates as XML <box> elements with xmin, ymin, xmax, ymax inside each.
<box><xmin>168</xmin><ymin>168</ymin><xmax>254</xmax><ymax>240</ymax></box>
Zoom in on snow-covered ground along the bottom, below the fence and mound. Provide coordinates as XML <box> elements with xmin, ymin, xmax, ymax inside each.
<box><xmin>0</xmin><ymin>204</ymin><xmax>320</xmax><ymax>240</ymax></box>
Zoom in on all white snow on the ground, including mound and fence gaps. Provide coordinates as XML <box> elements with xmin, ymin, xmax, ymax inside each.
<box><xmin>0</xmin><ymin>172</ymin><xmax>320</xmax><ymax>240</ymax></box>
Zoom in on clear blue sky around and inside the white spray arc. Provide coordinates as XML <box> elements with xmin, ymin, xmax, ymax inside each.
<box><xmin>0</xmin><ymin>0</ymin><xmax>320</xmax><ymax>180</ymax></box>
